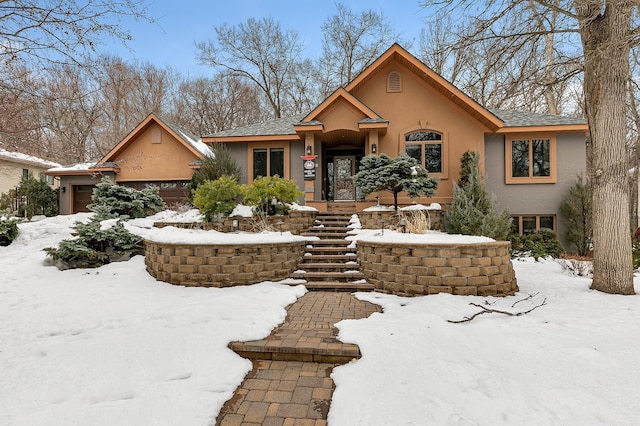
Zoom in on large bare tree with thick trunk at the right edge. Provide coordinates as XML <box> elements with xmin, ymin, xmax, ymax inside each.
<box><xmin>422</xmin><ymin>0</ymin><xmax>640</xmax><ymax>294</ymax></box>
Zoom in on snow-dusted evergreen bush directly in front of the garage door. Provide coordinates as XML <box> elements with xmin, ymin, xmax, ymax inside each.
<box><xmin>87</xmin><ymin>178</ymin><xmax>165</xmax><ymax>219</ymax></box>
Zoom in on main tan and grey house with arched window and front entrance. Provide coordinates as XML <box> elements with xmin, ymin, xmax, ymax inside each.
<box><xmin>202</xmin><ymin>44</ymin><xmax>588</xmax><ymax>245</ymax></box>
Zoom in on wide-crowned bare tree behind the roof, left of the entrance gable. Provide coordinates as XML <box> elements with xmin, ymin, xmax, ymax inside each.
<box><xmin>196</xmin><ymin>18</ymin><xmax>302</xmax><ymax>118</ymax></box>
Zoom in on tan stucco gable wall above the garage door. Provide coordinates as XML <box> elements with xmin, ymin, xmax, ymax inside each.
<box><xmin>111</xmin><ymin>123</ymin><xmax>198</xmax><ymax>182</ymax></box>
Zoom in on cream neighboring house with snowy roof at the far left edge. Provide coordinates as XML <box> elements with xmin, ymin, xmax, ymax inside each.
<box><xmin>0</xmin><ymin>148</ymin><xmax>60</xmax><ymax>194</ymax></box>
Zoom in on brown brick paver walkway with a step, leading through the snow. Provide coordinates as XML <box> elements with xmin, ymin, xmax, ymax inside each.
<box><xmin>216</xmin><ymin>291</ymin><xmax>380</xmax><ymax>426</ymax></box>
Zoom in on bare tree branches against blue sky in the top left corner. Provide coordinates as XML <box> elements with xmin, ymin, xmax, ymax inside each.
<box><xmin>0</xmin><ymin>0</ymin><xmax>151</xmax><ymax>65</ymax></box>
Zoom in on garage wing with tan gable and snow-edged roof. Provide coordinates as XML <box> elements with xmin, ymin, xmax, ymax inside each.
<box><xmin>46</xmin><ymin>114</ymin><xmax>211</xmax><ymax>214</ymax></box>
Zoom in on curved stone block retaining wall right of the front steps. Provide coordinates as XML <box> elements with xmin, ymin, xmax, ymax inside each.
<box><xmin>358</xmin><ymin>241</ymin><xmax>518</xmax><ymax>296</ymax></box>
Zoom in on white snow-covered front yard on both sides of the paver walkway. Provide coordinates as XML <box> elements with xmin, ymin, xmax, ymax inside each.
<box><xmin>0</xmin><ymin>215</ymin><xmax>640</xmax><ymax>426</ymax></box>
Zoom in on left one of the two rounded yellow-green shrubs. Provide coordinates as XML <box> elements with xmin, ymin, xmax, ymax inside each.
<box><xmin>193</xmin><ymin>176</ymin><xmax>240</xmax><ymax>221</ymax></box>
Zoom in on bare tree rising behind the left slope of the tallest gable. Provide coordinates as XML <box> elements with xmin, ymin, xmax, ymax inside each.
<box><xmin>318</xmin><ymin>3</ymin><xmax>399</xmax><ymax>96</ymax></box>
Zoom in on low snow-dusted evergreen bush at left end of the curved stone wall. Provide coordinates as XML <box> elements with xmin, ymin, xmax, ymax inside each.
<box><xmin>44</xmin><ymin>216</ymin><xmax>143</xmax><ymax>269</ymax></box>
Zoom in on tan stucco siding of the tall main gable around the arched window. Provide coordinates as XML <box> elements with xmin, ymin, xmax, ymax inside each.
<box><xmin>354</xmin><ymin>63</ymin><xmax>484</xmax><ymax>202</ymax></box>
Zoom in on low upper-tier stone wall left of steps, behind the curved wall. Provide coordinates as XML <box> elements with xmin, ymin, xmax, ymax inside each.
<box><xmin>153</xmin><ymin>210</ymin><xmax>318</xmax><ymax>235</ymax></box>
